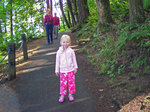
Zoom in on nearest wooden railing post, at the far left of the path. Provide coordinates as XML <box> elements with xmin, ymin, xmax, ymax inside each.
<box><xmin>8</xmin><ymin>43</ymin><xmax>16</xmax><ymax>80</ymax></box>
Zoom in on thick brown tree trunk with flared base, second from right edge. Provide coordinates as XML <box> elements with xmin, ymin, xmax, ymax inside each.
<box><xmin>96</xmin><ymin>0</ymin><xmax>113</xmax><ymax>29</ymax></box>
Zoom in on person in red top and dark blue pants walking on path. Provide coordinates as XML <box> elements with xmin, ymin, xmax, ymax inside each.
<box><xmin>44</xmin><ymin>9</ymin><xmax>54</xmax><ymax>44</ymax></box>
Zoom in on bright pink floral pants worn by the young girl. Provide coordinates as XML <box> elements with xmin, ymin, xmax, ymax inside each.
<box><xmin>60</xmin><ymin>71</ymin><xmax>76</xmax><ymax>95</ymax></box>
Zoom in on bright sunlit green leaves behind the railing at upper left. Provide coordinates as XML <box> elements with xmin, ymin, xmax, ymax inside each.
<box><xmin>0</xmin><ymin>0</ymin><xmax>44</xmax><ymax>63</ymax></box>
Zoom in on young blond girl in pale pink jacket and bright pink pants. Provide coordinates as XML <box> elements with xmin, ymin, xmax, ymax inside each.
<box><xmin>55</xmin><ymin>35</ymin><xmax>78</xmax><ymax>102</ymax></box>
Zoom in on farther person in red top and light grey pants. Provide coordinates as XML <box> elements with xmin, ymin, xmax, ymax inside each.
<box><xmin>53</xmin><ymin>13</ymin><xmax>60</xmax><ymax>39</ymax></box>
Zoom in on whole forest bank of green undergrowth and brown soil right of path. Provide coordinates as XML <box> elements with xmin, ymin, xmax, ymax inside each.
<box><xmin>72</xmin><ymin>11</ymin><xmax>150</xmax><ymax>112</ymax></box>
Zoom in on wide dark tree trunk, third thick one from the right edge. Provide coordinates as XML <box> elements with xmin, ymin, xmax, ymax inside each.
<box><xmin>78</xmin><ymin>0</ymin><xmax>89</xmax><ymax>22</ymax></box>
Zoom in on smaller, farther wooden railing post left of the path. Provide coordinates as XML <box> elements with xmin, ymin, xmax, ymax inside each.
<box><xmin>22</xmin><ymin>34</ymin><xmax>28</xmax><ymax>60</ymax></box>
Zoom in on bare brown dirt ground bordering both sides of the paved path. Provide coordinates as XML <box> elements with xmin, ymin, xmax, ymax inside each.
<box><xmin>1</xmin><ymin>34</ymin><xmax>150</xmax><ymax>112</ymax></box>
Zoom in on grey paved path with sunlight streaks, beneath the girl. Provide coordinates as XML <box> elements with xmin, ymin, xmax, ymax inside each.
<box><xmin>0</xmin><ymin>31</ymin><xmax>97</xmax><ymax>112</ymax></box>
